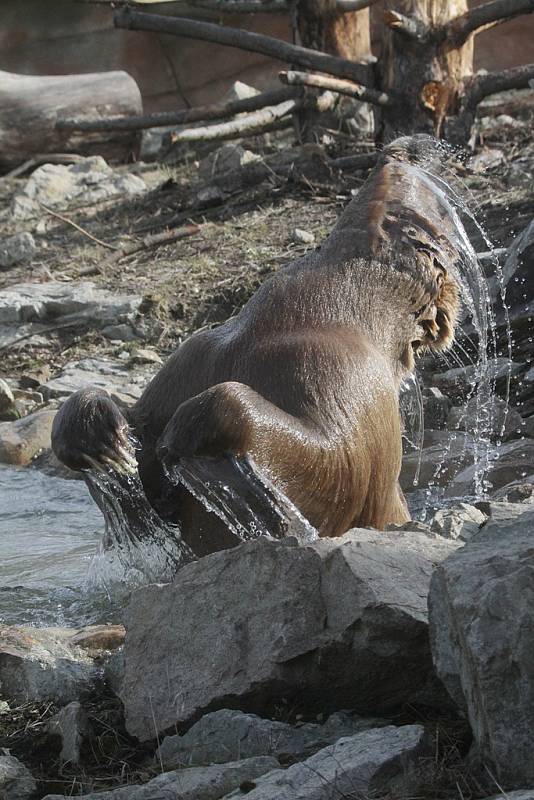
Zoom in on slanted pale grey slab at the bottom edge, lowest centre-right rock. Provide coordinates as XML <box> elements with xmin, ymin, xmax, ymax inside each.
<box><xmin>225</xmin><ymin>725</ymin><xmax>424</xmax><ymax>800</ymax></box>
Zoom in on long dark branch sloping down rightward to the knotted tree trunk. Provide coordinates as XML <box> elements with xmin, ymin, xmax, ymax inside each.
<box><xmin>113</xmin><ymin>6</ymin><xmax>372</xmax><ymax>84</ymax></box>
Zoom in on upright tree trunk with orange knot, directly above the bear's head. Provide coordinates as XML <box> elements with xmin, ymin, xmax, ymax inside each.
<box><xmin>381</xmin><ymin>0</ymin><xmax>473</xmax><ymax>141</ymax></box>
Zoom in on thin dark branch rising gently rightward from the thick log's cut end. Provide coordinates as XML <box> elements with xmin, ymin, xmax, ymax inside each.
<box><xmin>56</xmin><ymin>89</ymin><xmax>297</xmax><ymax>131</ymax></box>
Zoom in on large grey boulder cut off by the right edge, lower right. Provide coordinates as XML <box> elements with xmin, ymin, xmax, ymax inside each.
<box><xmin>429</xmin><ymin>506</ymin><xmax>534</xmax><ymax>788</ymax></box>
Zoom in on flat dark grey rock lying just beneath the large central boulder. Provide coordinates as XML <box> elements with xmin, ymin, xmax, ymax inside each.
<box><xmin>157</xmin><ymin>709</ymin><xmax>386</xmax><ymax>769</ymax></box>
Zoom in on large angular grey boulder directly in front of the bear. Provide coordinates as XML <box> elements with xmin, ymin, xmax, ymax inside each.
<box><xmin>121</xmin><ymin>530</ymin><xmax>457</xmax><ymax>740</ymax></box>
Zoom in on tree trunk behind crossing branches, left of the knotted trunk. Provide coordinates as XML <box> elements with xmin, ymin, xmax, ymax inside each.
<box><xmin>295</xmin><ymin>0</ymin><xmax>371</xmax><ymax>142</ymax></box>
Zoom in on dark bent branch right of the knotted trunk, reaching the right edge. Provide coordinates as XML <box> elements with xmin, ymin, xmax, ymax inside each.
<box><xmin>447</xmin><ymin>64</ymin><xmax>534</xmax><ymax>143</ymax></box>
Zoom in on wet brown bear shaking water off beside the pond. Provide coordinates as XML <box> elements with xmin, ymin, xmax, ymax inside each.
<box><xmin>53</xmin><ymin>136</ymin><xmax>464</xmax><ymax>555</ymax></box>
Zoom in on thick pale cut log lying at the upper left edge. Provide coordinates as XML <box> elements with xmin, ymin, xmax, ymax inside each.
<box><xmin>0</xmin><ymin>72</ymin><xmax>143</xmax><ymax>171</ymax></box>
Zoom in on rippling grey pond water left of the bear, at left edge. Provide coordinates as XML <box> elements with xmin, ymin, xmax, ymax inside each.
<box><xmin>0</xmin><ymin>465</ymin><xmax>110</xmax><ymax>625</ymax></box>
